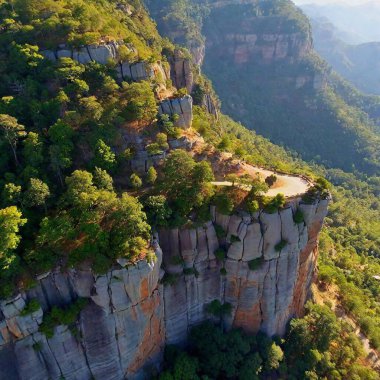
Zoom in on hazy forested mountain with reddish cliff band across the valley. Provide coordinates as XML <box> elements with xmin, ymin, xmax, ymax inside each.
<box><xmin>148</xmin><ymin>1</ymin><xmax>379</xmax><ymax>173</ymax></box>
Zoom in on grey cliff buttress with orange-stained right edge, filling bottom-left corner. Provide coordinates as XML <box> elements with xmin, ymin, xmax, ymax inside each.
<box><xmin>0</xmin><ymin>246</ymin><xmax>165</xmax><ymax>380</ymax></box>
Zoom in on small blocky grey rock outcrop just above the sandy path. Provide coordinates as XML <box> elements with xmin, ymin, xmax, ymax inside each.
<box><xmin>158</xmin><ymin>95</ymin><xmax>193</xmax><ymax>129</ymax></box>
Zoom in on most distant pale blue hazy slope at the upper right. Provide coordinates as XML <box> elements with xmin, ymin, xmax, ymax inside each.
<box><xmin>311</xmin><ymin>15</ymin><xmax>380</xmax><ymax>95</ymax></box>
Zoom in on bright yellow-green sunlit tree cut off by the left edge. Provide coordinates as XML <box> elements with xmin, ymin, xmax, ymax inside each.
<box><xmin>0</xmin><ymin>206</ymin><xmax>27</xmax><ymax>258</ymax></box>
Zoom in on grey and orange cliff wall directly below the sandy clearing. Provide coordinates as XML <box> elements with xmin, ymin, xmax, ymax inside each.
<box><xmin>160</xmin><ymin>196</ymin><xmax>328</xmax><ymax>343</ymax></box>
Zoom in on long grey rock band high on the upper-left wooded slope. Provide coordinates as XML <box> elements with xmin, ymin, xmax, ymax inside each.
<box><xmin>41</xmin><ymin>42</ymin><xmax>170</xmax><ymax>82</ymax></box>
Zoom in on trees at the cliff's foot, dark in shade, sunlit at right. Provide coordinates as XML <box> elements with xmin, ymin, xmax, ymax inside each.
<box><xmin>159</xmin><ymin>304</ymin><xmax>378</xmax><ymax>380</ymax></box>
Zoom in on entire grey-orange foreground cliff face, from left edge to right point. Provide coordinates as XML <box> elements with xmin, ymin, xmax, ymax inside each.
<box><xmin>0</xmin><ymin>200</ymin><xmax>328</xmax><ymax>380</ymax></box>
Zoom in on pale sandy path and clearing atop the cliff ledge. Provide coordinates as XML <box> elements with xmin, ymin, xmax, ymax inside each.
<box><xmin>212</xmin><ymin>163</ymin><xmax>311</xmax><ymax>198</ymax></box>
